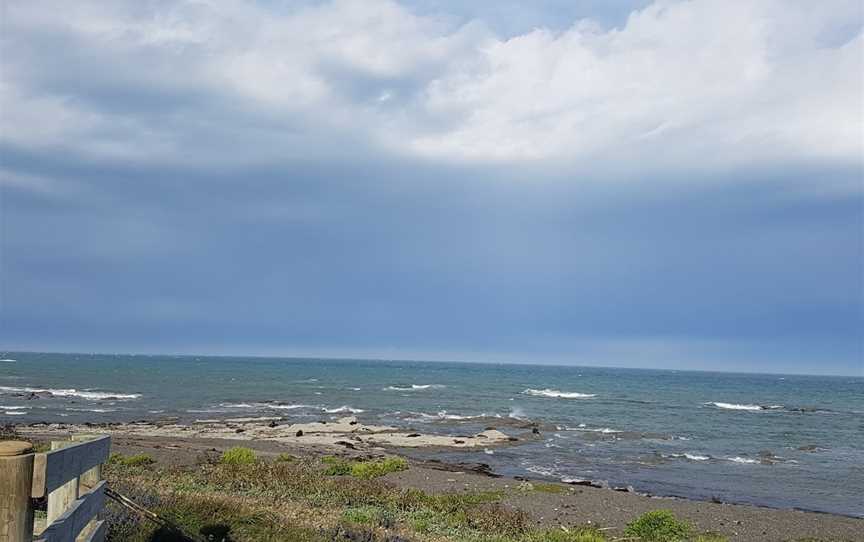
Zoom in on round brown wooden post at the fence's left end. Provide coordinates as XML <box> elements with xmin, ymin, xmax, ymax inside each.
<box><xmin>0</xmin><ymin>440</ymin><xmax>33</xmax><ymax>542</ymax></box>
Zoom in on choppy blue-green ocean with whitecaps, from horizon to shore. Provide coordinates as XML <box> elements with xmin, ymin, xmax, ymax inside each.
<box><xmin>0</xmin><ymin>353</ymin><xmax>864</xmax><ymax>517</ymax></box>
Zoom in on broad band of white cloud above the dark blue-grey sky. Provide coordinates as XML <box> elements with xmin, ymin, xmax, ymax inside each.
<box><xmin>0</xmin><ymin>0</ymin><xmax>864</xmax><ymax>169</ymax></box>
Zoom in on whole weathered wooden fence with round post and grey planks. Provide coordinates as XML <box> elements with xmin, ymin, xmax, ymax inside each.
<box><xmin>0</xmin><ymin>436</ymin><xmax>111</xmax><ymax>542</ymax></box>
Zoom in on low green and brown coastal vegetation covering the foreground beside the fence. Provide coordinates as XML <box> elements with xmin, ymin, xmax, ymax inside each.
<box><xmin>104</xmin><ymin>454</ymin><xmax>724</xmax><ymax>542</ymax></box>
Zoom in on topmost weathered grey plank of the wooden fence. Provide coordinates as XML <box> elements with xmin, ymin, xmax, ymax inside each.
<box><xmin>32</xmin><ymin>435</ymin><xmax>111</xmax><ymax>497</ymax></box>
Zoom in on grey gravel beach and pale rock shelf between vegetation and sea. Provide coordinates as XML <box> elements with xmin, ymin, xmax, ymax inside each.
<box><xmin>13</xmin><ymin>417</ymin><xmax>864</xmax><ymax>542</ymax></box>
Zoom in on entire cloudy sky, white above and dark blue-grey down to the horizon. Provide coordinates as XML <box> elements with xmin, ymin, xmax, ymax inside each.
<box><xmin>0</xmin><ymin>0</ymin><xmax>864</xmax><ymax>376</ymax></box>
